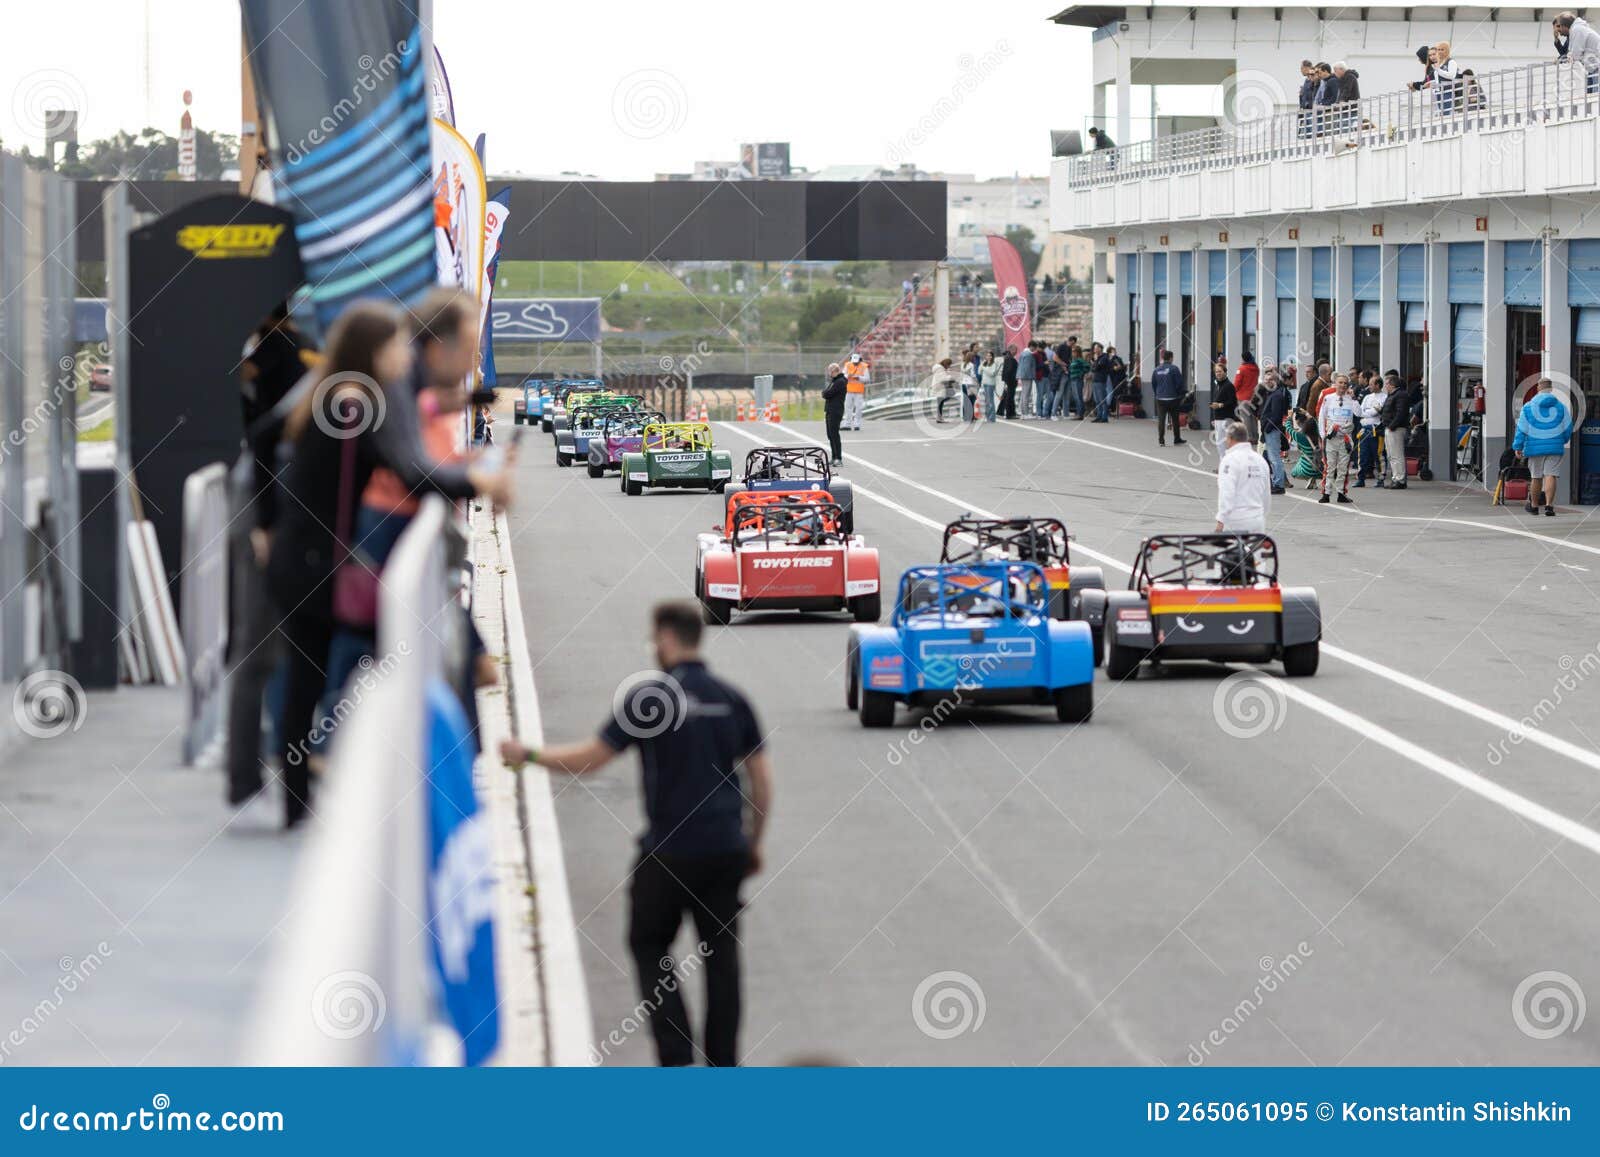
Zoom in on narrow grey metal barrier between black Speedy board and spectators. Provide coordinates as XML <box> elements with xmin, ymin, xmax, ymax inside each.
<box><xmin>178</xmin><ymin>462</ymin><xmax>229</xmax><ymax>767</ymax></box>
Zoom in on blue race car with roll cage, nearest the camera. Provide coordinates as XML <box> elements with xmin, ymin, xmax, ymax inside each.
<box><xmin>845</xmin><ymin>562</ymin><xmax>1094</xmax><ymax>727</ymax></box>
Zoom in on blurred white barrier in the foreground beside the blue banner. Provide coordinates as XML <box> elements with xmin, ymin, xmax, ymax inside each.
<box><xmin>243</xmin><ymin>496</ymin><xmax>461</xmax><ymax>1066</ymax></box>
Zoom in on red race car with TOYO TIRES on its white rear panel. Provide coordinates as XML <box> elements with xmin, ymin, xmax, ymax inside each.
<box><xmin>694</xmin><ymin>490</ymin><xmax>882</xmax><ymax>623</ymax></box>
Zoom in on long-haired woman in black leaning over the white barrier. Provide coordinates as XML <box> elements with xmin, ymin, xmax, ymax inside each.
<box><xmin>267</xmin><ymin>302</ymin><xmax>510</xmax><ymax>827</ymax></box>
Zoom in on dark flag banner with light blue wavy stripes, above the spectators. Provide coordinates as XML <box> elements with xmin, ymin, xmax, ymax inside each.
<box><xmin>240</xmin><ymin>0</ymin><xmax>435</xmax><ymax>328</ymax></box>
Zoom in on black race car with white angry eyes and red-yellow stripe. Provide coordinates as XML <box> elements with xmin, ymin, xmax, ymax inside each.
<box><xmin>1106</xmin><ymin>533</ymin><xmax>1322</xmax><ymax>679</ymax></box>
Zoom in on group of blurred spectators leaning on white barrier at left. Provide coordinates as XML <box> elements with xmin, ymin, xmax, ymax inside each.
<box><xmin>227</xmin><ymin>288</ymin><xmax>512</xmax><ymax>827</ymax></box>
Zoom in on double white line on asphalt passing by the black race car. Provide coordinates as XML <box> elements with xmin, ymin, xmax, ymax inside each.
<box><xmin>730</xmin><ymin>426</ymin><xmax>1600</xmax><ymax>855</ymax></box>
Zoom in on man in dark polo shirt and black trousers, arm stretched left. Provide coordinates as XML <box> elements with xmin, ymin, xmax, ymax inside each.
<box><xmin>501</xmin><ymin>602</ymin><xmax>773</xmax><ymax>1066</ymax></box>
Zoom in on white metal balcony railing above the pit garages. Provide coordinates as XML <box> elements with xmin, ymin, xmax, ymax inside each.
<box><xmin>1067</xmin><ymin>61</ymin><xmax>1600</xmax><ymax>189</ymax></box>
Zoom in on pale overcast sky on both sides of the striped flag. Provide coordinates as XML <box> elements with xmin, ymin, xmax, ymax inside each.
<box><xmin>0</xmin><ymin>0</ymin><xmax>1090</xmax><ymax>179</ymax></box>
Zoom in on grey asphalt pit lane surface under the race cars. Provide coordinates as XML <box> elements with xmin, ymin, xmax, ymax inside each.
<box><xmin>510</xmin><ymin>412</ymin><xmax>1600</xmax><ymax>1064</ymax></box>
